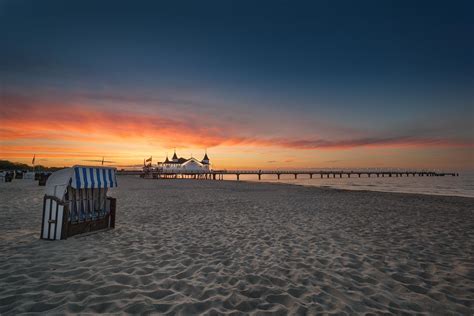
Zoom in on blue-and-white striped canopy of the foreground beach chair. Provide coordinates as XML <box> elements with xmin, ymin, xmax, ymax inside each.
<box><xmin>71</xmin><ymin>166</ymin><xmax>117</xmax><ymax>189</ymax></box>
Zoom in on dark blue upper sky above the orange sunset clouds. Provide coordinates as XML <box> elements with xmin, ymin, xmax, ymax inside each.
<box><xmin>0</xmin><ymin>0</ymin><xmax>474</xmax><ymax>168</ymax></box>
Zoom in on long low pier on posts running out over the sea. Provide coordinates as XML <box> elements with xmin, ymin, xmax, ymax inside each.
<box><xmin>130</xmin><ymin>170</ymin><xmax>459</xmax><ymax>180</ymax></box>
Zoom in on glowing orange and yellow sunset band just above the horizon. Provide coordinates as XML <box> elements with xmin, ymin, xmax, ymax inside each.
<box><xmin>0</xmin><ymin>90</ymin><xmax>472</xmax><ymax>168</ymax></box>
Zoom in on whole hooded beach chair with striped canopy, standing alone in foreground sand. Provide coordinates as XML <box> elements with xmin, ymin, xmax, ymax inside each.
<box><xmin>41</xmin><ymin>166</ymin><xmax>117</xmax><ymax>240</ymax></box>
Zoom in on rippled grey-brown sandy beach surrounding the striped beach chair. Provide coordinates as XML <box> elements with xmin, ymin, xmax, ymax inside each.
<box><xmin>0</xmin><ymin>176</ymin><xmax>474</xmax><ymax>315</ymax></box>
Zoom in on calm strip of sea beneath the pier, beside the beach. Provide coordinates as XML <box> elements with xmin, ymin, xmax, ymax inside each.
<box><xmin>224</xmin><ymin>171</ymin><xmax>474</xmax><ymax>197</ymax></box>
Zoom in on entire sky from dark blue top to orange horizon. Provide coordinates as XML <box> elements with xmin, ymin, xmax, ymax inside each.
<box><xmin>0</xmin><ymin>0</ymin><xmax>474</xmax><ymax>170</ymax></box>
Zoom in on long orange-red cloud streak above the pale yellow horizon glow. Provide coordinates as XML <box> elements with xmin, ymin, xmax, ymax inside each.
<box><xmin>0</xmin><ymin>93</ymin><xmax>473</xmax><ymax>150</ymax></box>
